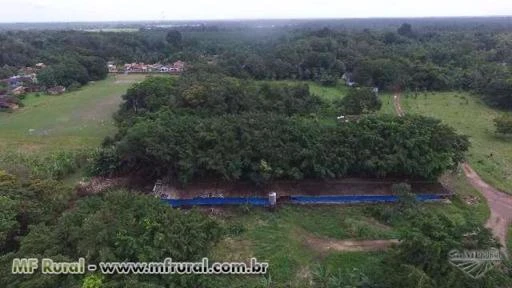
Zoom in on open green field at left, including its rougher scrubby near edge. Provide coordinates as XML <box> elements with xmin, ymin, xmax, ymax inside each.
<box><xmin>0</xmin><ymin>75</ymin><xmax>151</xmax><ymax>180</ymax></box>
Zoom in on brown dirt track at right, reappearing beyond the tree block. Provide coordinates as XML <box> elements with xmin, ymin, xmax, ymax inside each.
<box><xmin>393</xmin><ymin>95</ymin><xmax>512</xmax><ymax>255</ymax></box>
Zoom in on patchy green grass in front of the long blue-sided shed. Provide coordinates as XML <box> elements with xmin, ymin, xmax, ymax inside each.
<box><xmin>213</xmin><ymin>206</ymin><xmax>397</xmax><ymax>287</ymax></box>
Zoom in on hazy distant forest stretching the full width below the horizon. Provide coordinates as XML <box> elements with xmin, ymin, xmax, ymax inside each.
<box><xmin>0</xmin><ymin>22</ymin><xmax>512</xmax><ymax>109</ymax></box>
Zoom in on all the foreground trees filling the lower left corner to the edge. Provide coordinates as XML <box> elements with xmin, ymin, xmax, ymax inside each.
<box><xmin>0</xmin><ymin>171</ymin><xmax>222</xmax><ymax>287</ymax></box>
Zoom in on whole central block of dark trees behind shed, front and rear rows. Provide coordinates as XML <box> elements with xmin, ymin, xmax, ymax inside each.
<box><xmin>93</xmin><ymin>72</ymin><xmax>467</xmax><ymax>184</ymax></box>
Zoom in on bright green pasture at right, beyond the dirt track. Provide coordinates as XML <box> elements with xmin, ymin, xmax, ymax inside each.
<box><xmin>390</xmin><ymin>92</ymin><xmax>512</xmax><ymax>193</ymax></box>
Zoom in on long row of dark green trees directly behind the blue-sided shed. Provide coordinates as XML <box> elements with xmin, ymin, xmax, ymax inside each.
<box><xmin>98</xmin><ymin>111</ymin><xmax>468</xmax><ymax>183</ymax></box>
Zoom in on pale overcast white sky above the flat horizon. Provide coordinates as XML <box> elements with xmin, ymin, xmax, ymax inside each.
<box><xmin>0</xmin><ymin>0</ymin><xmax>512</xmax><ymax>22</ymax></box>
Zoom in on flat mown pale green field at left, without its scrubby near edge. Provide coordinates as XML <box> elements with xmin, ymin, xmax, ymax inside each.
<box><xmin>0</xmin><ymin>75</ymin><xmax>145</xmax><ymax>152</ymax></box>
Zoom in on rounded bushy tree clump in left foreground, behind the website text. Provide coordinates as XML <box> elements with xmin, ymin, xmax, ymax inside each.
<box><xmin>0</xmin><ymin>187</ymin><xmax>221</xmax><ymax>287</ymax></box>
